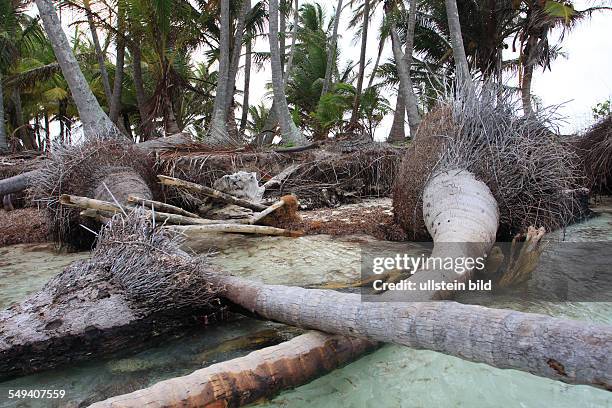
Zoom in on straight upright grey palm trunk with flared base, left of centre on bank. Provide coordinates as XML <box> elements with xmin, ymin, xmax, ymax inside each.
<box><xmin>206</xmin><ymin>1</ymin><xmax>231</xmax><ymax>146</ymax></box>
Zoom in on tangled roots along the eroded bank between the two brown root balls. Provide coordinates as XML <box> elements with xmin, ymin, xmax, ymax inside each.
<box><xmin>158</xmin><ymin>143</ymin><xmax>401</xmax><ymax>208</ymax></box>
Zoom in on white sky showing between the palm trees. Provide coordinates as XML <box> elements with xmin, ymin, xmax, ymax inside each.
<box><xmin>44</xmin><ymin>0</ymin><xmax>612</xmax><ymax>140</ymax></box>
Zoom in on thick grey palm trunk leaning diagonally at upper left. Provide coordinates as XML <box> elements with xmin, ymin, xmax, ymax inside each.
<box><xmin>36</xmin><ymin>0</ymin><xmax>124</xmax><ymax>138</ymax></box>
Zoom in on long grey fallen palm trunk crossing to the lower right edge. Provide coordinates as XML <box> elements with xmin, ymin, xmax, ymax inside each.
<box><xmin>212</xmin><ymin>276</ymin><xmax>612</xmax><ymax>390</ymax></box>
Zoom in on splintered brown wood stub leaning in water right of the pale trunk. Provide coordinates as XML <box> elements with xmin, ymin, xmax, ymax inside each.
<box><xmin>498</xmin><ymin>226</ymin><xmax>546</xmax><ymax>288</ymax></box>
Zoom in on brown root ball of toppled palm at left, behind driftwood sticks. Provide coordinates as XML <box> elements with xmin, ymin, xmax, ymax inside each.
<box><xmin>28</xmin><ymin>138</ymin><xmax>159</xmax><ymax>249</ymax></box>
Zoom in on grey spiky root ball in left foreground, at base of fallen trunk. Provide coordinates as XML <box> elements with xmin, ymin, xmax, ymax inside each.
<box><xmin>92</xmin><ymin>210</ymin><xmax>220</xmax><ymax>315</ymax></box>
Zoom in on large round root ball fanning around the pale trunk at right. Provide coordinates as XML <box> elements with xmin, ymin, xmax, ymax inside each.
<box><xmin>393</xmin><ymin>87</ymin><xmax>580</xmax><ymax>239</ymax></box>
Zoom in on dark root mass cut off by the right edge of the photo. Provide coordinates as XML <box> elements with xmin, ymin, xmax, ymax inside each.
<box><xmin>575</xmin><ymin>116</ymin><xmax>612</xmax><ymax>194</ymax></box>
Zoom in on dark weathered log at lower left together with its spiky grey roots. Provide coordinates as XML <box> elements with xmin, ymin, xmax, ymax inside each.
<box><xmin>0</xmin><ymin>216</ymin><xmax>227</xmax><ymax>380</ymax></box>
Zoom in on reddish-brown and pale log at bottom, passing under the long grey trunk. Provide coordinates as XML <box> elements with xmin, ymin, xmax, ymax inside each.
<box><xmin>91</xmin><ymin>332</ymin><xmax>375</xmax><ymax>408</ymax></box>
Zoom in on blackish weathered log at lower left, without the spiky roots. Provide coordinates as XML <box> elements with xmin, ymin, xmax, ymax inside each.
<box><xmin>0</xmin><ymin>261</ymin><xmax>225</xmax><ymax>381</ymax></box>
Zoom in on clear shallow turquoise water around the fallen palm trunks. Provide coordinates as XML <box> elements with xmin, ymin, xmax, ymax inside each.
<box><xmin>0</xmin><ymin>206</ymin><xmax>612</xmax><ymax>408</ymax></box>
